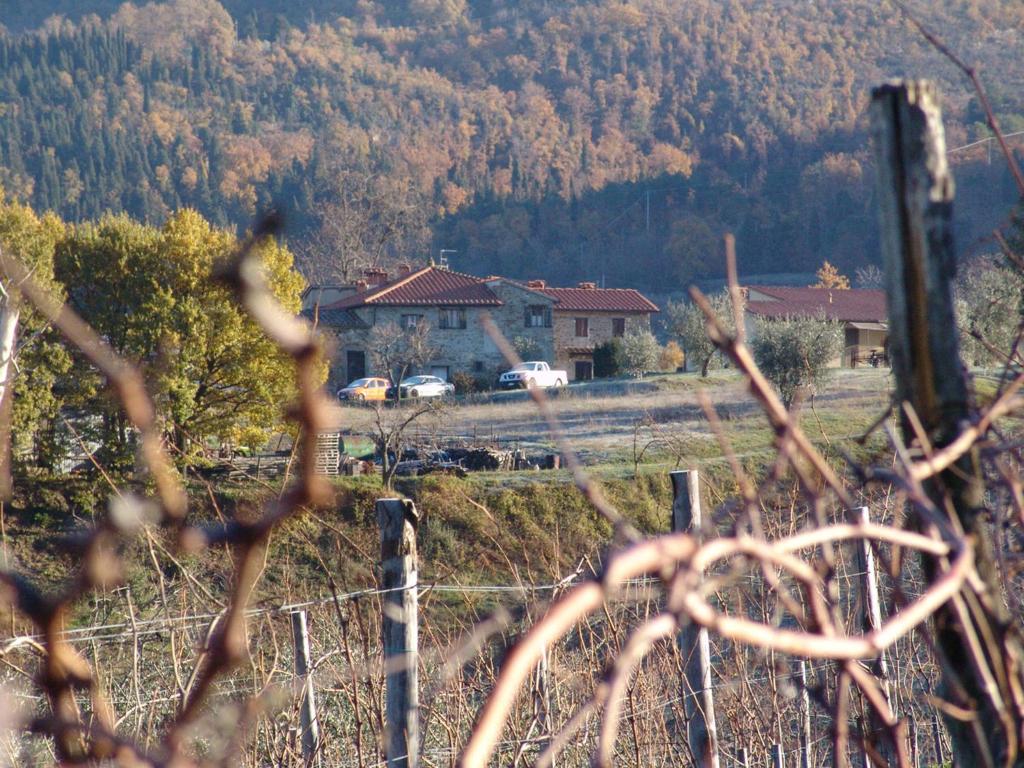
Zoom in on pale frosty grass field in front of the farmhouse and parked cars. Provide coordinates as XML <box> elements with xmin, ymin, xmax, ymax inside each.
<box><xmin>342</xmin><ymin>369</ymin><xmax>890</xmax><ymax>474</ymax></box>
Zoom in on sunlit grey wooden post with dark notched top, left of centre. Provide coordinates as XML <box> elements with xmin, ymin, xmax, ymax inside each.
<box><xmin>377</xmin><ymin>499</ymin><xmax>420</xmax><ymax>768</ymax></box>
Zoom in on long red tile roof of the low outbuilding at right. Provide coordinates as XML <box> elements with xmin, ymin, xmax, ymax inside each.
<box><xmin>746</xmin><ymin>286</ymin><xmax>888</xmax><ymax>323</ymax></box>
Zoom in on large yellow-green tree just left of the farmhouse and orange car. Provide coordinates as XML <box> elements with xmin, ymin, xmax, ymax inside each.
<box><xmin>57</xmin><ymin>210</ymin><xmax>303</xmax><ymax>456</ymax></box>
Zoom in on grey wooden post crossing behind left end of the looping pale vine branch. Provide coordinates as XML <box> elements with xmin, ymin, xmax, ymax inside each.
<box><xmin>670</xmin><ymin>469</ymin><xmax>720</xmax><ymax>768</ymax></box>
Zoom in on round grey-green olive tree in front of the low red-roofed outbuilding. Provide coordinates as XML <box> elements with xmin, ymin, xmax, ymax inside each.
<box><xmin>751</xmin><ymin>317</ymin><xmax>843</xmax><ymax>408</ymax></box>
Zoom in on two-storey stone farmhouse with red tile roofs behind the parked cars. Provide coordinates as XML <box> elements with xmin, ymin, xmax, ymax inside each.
<box><xmin>303</xmin><ymin>264</ymin><xmax>658</xmax><ymax>385</ymax></box>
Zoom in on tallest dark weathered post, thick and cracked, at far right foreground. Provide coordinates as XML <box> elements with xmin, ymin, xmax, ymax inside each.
<box><xmin>870</xmin><ymin>81</ymin><xmax>1024</xmax><ymax>768</ymax></box>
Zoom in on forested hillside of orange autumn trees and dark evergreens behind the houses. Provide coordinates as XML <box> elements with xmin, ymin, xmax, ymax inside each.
<box><xmin>0</xmin><ymin>0</ymin><xmax>1024</xmax><ymax>287</ymax></box>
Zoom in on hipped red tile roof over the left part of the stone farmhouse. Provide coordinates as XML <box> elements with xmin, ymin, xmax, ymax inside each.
<box><xmin>324</xmin><ymin>266</ymin><xmax>502</xmax><ymax>309</ymax></box>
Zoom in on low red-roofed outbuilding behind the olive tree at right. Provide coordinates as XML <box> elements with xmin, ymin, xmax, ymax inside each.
<box><xmin>743</xmin><ymin>286</ymin><xmax>889</xmax><ymax>368</ymax></box>
